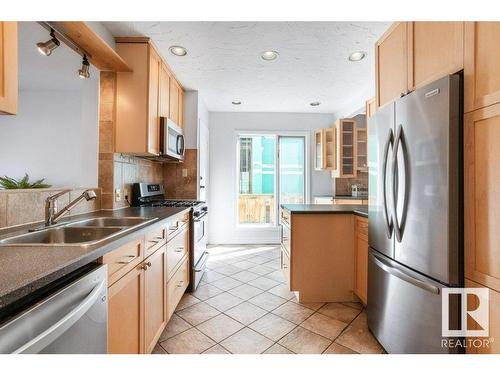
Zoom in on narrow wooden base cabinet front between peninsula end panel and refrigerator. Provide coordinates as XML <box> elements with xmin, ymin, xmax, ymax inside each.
<box><xmin>354</xmin><ymin>216</ymin><xmax>368</xmax><ymax>305</ymax></box>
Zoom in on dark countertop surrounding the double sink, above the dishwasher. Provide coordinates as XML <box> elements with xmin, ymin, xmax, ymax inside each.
<box><xmin>0</xmin><ymin>207</ymin><xmax>189</xmax><ymax>312</ymax></box>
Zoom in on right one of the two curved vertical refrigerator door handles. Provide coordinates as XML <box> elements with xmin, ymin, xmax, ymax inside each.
<box><xmin>392</xmin><ymin>124</ymin><xmax>408</xmax><ymax>242</ymax></box>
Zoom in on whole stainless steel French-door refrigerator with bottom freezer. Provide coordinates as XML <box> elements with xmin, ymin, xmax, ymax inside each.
<box><xmin>367</xmin><ymin>74</ymin><xmax>463</xmax><ymax>353</ymax></box>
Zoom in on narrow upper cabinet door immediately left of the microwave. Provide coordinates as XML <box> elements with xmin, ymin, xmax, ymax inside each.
<box><xmin>148</xmin><ymin>48</ymin><xmax>161</xmax><ymax>155</ymax></box>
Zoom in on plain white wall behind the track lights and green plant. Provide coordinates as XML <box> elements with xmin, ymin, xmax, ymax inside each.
<box><xmin>0</xmin><ymin>22</ymin><xmax>99</xmax><ymax>187</ymax></box>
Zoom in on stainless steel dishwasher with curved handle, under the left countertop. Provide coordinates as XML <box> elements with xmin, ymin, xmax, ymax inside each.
<box><xmin>0</xmin><ymin>265</ymin><xmax>108</xmax><ymax>354</ymax></box>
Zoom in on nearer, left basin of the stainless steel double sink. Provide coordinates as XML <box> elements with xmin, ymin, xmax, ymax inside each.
<box><xmin>0</xmin><ymin>226</ymin><xmax>123</xmax><ymax>245</ymax></box>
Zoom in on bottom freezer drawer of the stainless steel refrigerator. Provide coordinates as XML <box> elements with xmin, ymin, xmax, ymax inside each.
<box><xmin>367</xmin><ymin>249</ymin><xmax>458</xmax><ymax>354</ymax></box>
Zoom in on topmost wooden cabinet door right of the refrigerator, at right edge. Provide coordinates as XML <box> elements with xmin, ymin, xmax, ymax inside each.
<box><xmin>464</xmin><ymin>22</ymin><xmax>500</xmax><ymax>112</ymax></box>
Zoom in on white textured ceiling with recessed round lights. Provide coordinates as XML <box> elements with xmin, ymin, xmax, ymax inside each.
<box><xmin>104</xmin><ymin>22</ymin><xmax>389</xmax><ymax>115</ymax></box>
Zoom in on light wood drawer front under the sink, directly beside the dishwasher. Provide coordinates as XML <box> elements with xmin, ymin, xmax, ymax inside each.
<box><xmin>102</xmin><ymin>239</ymin><xmax>144</xmax><ymax>285</ymax></box>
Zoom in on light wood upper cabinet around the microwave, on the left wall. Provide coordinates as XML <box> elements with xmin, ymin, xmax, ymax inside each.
<box><xmin>115</xmin><ymin>38</ymin><xmax>183</xmax><ymax>156</ymax></box>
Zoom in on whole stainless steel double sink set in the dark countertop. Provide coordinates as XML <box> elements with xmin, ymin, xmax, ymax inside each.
<box><xmin>0</xmin><ymin>217</ymin><xmax>157</xmax><ymax>246</ymax></box>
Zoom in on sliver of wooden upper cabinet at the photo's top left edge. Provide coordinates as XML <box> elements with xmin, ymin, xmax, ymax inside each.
<box><xmin>0</xmin><ymin>22</ymin><xmax>18</xmax><ymax>115</ymax></box>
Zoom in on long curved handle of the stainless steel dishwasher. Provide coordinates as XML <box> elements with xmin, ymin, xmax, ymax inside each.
<box><xmin>12</xmin><ymin>280</ymin><xmax>106</xmax><ymax>354</ymax></box>
